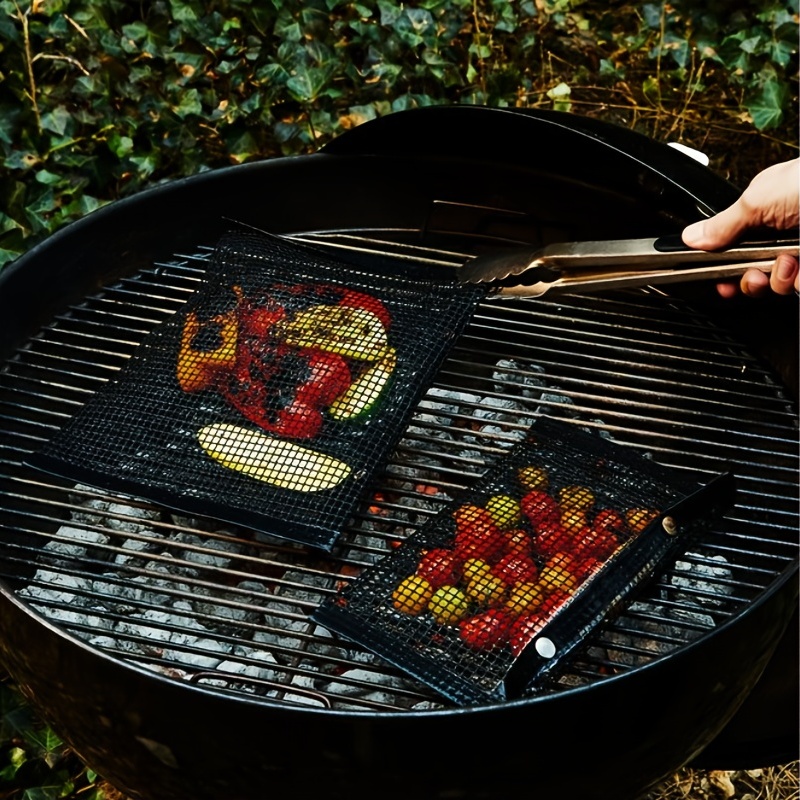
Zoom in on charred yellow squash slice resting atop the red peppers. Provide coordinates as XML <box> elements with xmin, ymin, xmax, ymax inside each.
<box><xmin>275</xmin><ymin>305</ymin><xmax>388</xmax><ymax>361</ymax></box>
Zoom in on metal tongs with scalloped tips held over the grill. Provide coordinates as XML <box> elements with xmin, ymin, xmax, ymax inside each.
<box><xmin>458</xmin><ymin>234</ymin><xmax>800</xmax><ymax>297</ymax></box>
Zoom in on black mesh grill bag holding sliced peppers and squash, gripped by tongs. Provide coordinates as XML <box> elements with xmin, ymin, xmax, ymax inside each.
<box><xmin>30</xmin><ymin>232</ymin><xmax>486</xmax><ymax>550</ymax></box>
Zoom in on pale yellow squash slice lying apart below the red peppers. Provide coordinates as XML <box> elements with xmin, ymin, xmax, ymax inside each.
<box><xmin>197</xmin><ymin>423</ymin><xmax>351</xmax><ymax>492</ymax></box>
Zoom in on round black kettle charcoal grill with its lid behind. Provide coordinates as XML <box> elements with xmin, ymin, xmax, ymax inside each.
<box><xmin>0</xmin><ymin>107</ymin><xmax>798</xmax><ymax>800</ymax></box>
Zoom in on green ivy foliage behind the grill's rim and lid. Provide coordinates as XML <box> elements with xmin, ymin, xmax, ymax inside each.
<box><xmin>0</xmin><ymin>0</ymin><xmax>798</xmax><ymax>264</ymax></box>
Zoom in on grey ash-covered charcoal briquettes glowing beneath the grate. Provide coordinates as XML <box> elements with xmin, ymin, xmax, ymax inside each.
<box><xmin>18</xmin><ymin>359</ymin><xmax>729</xmax><ymax>711</ymax></box>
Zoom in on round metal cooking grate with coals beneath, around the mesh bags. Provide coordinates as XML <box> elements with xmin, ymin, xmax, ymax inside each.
<box><xmin>0</xmin><ymin>230</ymin><xmax>798</xmax><ymax>711</ymax></box>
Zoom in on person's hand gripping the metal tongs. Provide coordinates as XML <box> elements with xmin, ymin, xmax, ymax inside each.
<box><xmin>682</xmin><ymin>158</ymin><xmax>800</xmax><ymax>297</ymax></box>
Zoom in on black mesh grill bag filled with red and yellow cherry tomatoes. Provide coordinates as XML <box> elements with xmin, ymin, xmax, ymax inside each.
<box><xmin>312</xmin><ymin>417</ymin><xmax>734</xmax><ymax>705</ymax></box>
